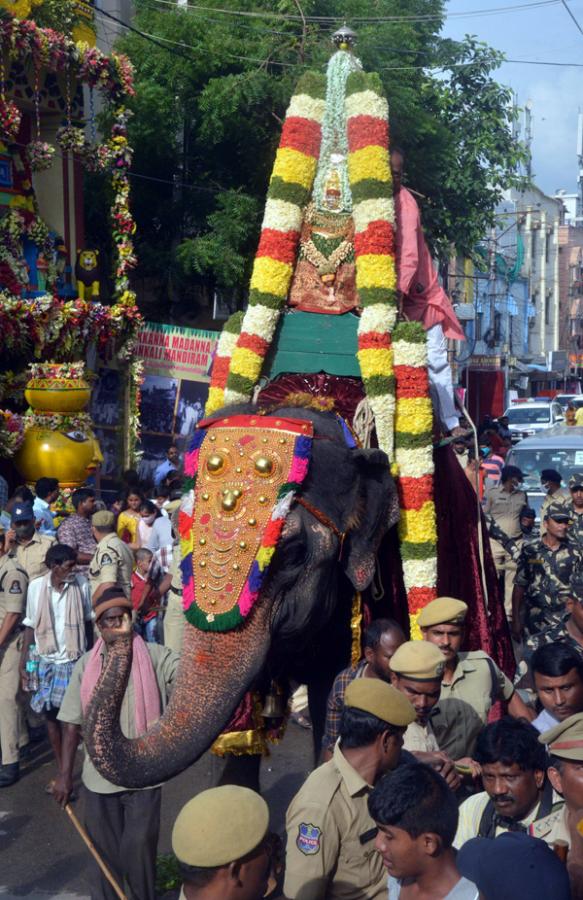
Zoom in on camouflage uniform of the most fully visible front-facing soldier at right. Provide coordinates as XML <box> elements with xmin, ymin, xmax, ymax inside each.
<box><xmin>514</xmin><ymin>538</ymin><xmax>583</xmax><ymax>637</ymax></box>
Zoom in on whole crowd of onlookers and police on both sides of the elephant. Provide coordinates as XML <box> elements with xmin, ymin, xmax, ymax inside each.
<box><xmin>0</xmin><ymin>423</ymin><xmax>583</xmax><ymax>900</ymax></box>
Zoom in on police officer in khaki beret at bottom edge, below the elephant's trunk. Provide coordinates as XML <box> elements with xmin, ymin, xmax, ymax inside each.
<box><xmin>172</xmin><ymin>784</ymin><xmax>271</xmax><ymax>900</ymax></box>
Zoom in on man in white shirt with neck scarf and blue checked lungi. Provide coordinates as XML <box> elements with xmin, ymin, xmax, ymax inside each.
<box><xmin>20</xmin><ymin>544</ymin><xmax>93</xmax><ymax>769</ymax></box>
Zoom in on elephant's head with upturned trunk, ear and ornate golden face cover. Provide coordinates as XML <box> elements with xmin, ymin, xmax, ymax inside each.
<box><xmin>84</xmin><ymin>405</ymin><xmax>398</xmax><ymax>788</ymax></box>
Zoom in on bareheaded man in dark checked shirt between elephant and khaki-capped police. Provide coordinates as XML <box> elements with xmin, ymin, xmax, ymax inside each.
<box><xmin>322</xmin><ymin>619</ymin><xmax>405</xmax><ymax>762</ymax></box>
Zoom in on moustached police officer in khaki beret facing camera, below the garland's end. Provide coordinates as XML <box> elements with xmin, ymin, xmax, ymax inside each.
<box><xmin>417</xmin><ymin>597</ymin><xmax>534</xmax><ymax>760</ymax></box>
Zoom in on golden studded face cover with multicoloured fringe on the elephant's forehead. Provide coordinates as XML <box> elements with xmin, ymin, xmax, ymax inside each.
<box><xmin>179</xmin><ymin>415</ymin><xmax>313</xmax><ymax>631</ymax></box>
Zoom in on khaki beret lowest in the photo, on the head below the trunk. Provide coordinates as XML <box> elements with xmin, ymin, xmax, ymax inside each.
<box><xmin>172</xmin><ymin>784</ymin><xmax>269</xmax><ymax>869</ymax></box>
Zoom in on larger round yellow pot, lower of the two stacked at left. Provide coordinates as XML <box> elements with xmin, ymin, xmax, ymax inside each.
<box><xmin>14</xmin><ymin>428</ymin><xmax>103</xmax><ymax>487</ymax></box>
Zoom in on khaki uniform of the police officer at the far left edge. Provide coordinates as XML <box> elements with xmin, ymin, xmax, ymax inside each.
<box><xmin>0</xmin><ymin>556</ymin><xmax>28</xmax><ymax>765</ymax></box>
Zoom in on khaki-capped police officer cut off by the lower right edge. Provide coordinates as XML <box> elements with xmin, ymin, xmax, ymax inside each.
<box><xmin>531</xmin><ymin>713</ymin><xmax>583</xmax><ymax>897</ymax></box>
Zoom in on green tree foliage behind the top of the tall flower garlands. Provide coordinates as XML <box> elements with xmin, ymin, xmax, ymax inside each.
<box><xmin>120</xmin><ymin>0</ymin><xmax>524</xmax><ymax>322</ymax></box>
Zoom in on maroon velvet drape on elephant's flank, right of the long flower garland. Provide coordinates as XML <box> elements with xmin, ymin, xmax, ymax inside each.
<box><xmin>434</xmin><ymin>446</ymin><xmax>516</xmax><ymax>678</ymax></box>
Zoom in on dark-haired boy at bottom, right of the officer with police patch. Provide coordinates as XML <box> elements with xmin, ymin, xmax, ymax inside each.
<box><xmin>368</xmin><ymin>763</ymin><xmax>480</xmax><ymax>900</ymax></box>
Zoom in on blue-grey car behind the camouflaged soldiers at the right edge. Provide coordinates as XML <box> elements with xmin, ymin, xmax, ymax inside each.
<box><xmin>506</xmin><ymin>425</ymin><xmax>583</xmax><ymax>519</ymax></box>
